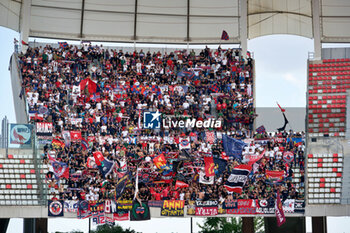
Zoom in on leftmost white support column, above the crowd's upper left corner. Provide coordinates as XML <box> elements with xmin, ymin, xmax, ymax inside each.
<box><xmin>19</xmin><ymin>0</ymin><xmax>32</xmax><ymax>52</ymax></box>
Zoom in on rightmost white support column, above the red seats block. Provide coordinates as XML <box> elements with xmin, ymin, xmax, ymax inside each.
<box><xmin>312</xmin><ymin>0</ymin><xmax>322</xmax><ymax>60</ymax></box>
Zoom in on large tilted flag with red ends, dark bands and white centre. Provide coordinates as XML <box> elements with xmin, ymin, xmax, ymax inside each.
<box><xmin>224</xmin><ymin>164</ymin><xmax>252</xmax><ymax>193</ymax></box>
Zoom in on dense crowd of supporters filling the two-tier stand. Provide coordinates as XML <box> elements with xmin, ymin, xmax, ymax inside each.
<box><xmin>20</xmin><ymin>43</ymin><xmax>304</xmax><ymax>205</ymax></box>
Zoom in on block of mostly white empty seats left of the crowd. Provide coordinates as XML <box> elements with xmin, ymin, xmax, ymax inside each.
<box><xmin>0</xmin><ymin>149</ymin><xmax>45</xmax><ymax>206</ymax></box>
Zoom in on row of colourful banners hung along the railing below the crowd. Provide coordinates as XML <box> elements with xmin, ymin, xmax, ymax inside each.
<box><xmin>48</xmin><ymin>199</ymin><xmax>305</xmax><ymax>225</ymax></box>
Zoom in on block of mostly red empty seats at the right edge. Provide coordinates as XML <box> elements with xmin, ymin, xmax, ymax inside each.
<box><xmin>308</xmin><ymin>58</ymin><xmax>350</xmax><ymax>137</ymax></box>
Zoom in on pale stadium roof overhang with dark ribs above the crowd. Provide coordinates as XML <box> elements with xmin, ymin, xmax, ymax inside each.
<box><xmin>0</xmin><ymin>0</ymin><xmax>350</xmax><ymax>43</ymax></box>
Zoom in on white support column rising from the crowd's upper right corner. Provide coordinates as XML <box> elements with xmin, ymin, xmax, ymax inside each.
<box><xmin>239</xmin><ymin>0</ymin><xmax>248</xmax><ymax>59</ymax></box>
